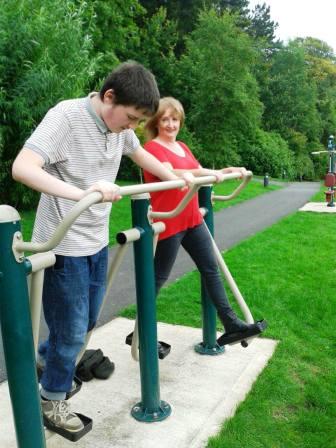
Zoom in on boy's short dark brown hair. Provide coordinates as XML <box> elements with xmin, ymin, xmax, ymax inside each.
<box><xmin>99</xmin><ymin>61</ymin><xmax>160</xmax><ymax>115</ymax></box>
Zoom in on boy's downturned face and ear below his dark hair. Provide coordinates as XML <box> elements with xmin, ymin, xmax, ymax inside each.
<box><xmin>100</xmin><ymin>90</ymin><xmax>147</xmax><ymax>132</ymax></box>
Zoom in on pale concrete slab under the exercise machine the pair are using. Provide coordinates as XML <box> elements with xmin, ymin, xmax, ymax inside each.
<box><xmin>0</xmin><ymin>318</ymin><xmax>276</xmax><ymax>448</ymax></box>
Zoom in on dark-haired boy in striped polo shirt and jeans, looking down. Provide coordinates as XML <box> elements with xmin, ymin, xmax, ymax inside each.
<box><xmin>12</xmin><ymin>62</ymin><xmax>186</xmax><ymax>432</ymax></box>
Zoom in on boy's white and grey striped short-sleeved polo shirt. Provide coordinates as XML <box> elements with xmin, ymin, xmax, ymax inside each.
<box><xmin>24</xmin><ymin>93</ymin><xmax>140</xmax><ymax>257</ymax></box>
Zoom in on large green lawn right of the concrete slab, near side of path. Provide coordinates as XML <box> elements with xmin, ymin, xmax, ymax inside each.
<box><xmin>122</xmin><ymin>212</ymin><xmax>336</xmax><ymax>448</ymax></box>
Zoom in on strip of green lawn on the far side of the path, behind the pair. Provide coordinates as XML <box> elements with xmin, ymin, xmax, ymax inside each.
<box><xmin>20</xmin><ymin>180</ymin><xmax>281</xmax><ymax>245</ymax></box>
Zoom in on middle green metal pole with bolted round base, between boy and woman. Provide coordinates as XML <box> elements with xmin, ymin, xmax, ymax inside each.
<box><xmin>131</xmin><ymin>194</ymin><xmax>171</xmax><ymax>422</ymax></box>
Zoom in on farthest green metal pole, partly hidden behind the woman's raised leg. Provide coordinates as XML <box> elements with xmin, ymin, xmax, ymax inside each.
<box><xmin>195</xmin><ymin>185</ymin><xmax>224</xmax><ymax>355</ymax></box>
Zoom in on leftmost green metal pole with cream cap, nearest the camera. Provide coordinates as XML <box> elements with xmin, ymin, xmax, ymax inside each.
<box><xmin>0</xmin><ymin>205</ymin><xmax>46</xmax><ymax>448</ymax></box>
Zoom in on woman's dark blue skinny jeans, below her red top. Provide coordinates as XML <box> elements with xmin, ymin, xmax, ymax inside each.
<box><xmin>154</xmin><ymin>221</ymin><xmax>232</xmax><ymax>323</ymax></box>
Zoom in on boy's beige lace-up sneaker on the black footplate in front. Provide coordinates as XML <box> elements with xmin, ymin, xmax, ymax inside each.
<box><xmin>41</xmin><ymin>398</ymin><xmax>84</xmax><ymax>432</ymax></box>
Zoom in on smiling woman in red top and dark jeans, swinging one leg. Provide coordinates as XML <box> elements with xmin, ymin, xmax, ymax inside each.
<box><xmin>144</xmin><ymin>97</ymin><xmax>254</xmax><ymax>344</ymax></box>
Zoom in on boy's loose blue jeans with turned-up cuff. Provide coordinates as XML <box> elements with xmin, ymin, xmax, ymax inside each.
<box><xmin>39</xmin><ymin>247</ymin><xmax>108</xmax><ymax>400</ymax></box>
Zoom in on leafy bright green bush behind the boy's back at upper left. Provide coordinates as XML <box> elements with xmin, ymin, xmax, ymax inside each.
<box><xmin>0</xmin><ymin>0</ymin><xmax>96</xmax><ymax>207</ymax></box>
